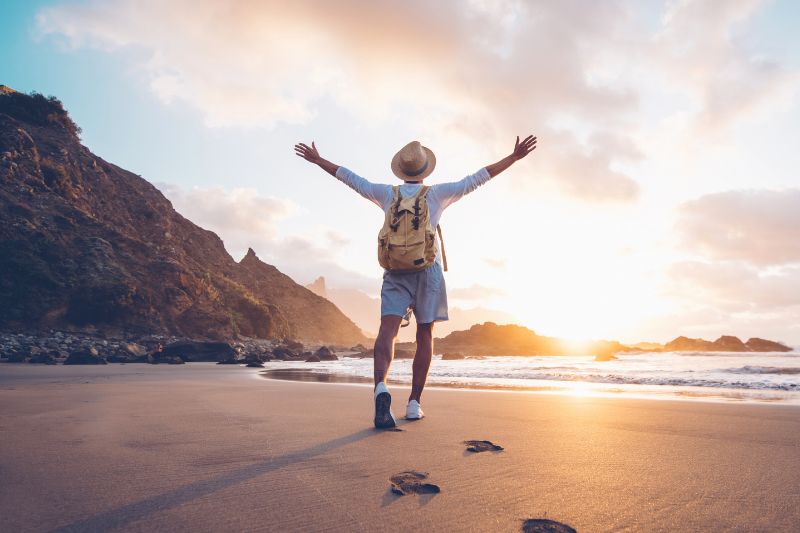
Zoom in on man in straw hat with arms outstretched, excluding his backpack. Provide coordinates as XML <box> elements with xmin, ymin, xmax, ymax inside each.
<box><xmin>294</xmin><ymin>135</ymin><xmax>536</xmax><ymax>428</ymax></box>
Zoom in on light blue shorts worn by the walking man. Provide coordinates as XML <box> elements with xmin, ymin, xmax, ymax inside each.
<box><xmin>381</xmin><ymin>263</ymin><xmax>448</xmax><ymax>324</ymax></box>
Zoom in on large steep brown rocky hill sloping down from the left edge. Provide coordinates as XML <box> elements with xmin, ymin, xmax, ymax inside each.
<box><xmin>0</xmin><ymin>86</ymin><xmax>366</xmax><ymax>345</ymax></box>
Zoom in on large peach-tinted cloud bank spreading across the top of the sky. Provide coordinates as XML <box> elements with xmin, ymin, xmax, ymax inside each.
<box><xmin>37</xmin><ymin>0</ymin><xmax>656</xmax><ymax>201</ymax></box>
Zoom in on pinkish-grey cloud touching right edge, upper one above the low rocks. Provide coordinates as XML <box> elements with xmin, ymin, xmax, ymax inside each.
<box><xmin>677</xmin><ymin>189</ymin><xmax>800</xmax><ymax>266</ymax></box>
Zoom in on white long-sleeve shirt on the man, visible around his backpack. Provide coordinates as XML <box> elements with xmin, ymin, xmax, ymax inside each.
<box><xmin>336</xmin><ymin>167</ymin><xmax>492</xmax><ymax>263</ymax></box>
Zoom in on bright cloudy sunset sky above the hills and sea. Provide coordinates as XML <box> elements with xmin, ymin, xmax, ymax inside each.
<box><xmin>0</xmin><ymin>0</ymin><xmax>800</xmax><ymax>345</ymax></box>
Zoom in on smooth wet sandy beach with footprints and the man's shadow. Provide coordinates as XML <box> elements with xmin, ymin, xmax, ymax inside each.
<box><xmin>0</xmin><ymin>364</ymin><xmax>800</xmax><ymax>532</ymax></box>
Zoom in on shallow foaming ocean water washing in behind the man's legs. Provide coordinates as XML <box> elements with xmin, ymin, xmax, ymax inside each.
<box><xmin>266</xmin><ymin>351</ymin><xmax>800</xmax><ymax>405</ymax></box>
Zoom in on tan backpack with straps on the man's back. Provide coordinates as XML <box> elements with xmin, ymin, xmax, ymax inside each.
<box><xmin>378</xmin><ymin>185</ymin><xmax>447</xmax><ymax>272</ymax></box>
